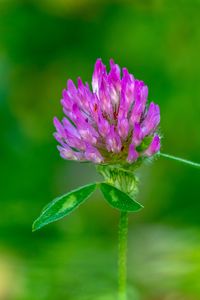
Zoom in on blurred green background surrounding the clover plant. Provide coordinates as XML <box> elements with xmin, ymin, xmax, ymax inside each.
<box><xmin>0</xmin><ymin>0</ymin><xmax>200</xmax><ymax>300</ymax></box>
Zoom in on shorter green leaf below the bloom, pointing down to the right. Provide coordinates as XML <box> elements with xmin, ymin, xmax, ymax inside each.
<box><xmin>100</xmin><ymin>183</ymin><xmax>143</xmax><ymax>212</ymax></box>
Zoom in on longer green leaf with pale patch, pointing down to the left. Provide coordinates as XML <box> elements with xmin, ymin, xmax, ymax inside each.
<box><xmin>33</xmin><ymin>183</ymin><xmax>97</xmax><ymax>231</ymax></box>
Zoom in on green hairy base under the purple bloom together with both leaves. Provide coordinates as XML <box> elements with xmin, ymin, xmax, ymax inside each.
<box><xmin>33</xmin><ymin>166</ymin><xmax>143</xmax><ymax>231</ymax></box>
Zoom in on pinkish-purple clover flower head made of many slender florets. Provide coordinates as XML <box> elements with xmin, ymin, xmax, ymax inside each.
<box><xmin>54</xmin><ymin>59</ymin><xmax>160</xmax><ymax>164</ymax></box>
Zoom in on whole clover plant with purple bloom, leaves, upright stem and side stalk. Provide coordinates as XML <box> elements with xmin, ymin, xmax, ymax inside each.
<box><xmin>33</xmin><ymin>59</ymin><xmax>200</xmax><ymax>300</ymax></box>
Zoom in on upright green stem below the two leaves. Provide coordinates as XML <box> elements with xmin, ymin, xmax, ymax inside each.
<box><xmin>118</xmin><ymin>211</ymin><xmax>128</xmax><ymax>300</ymax></box>
